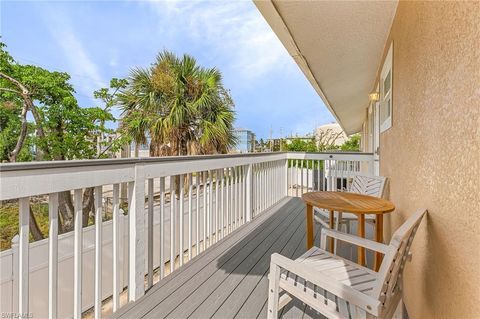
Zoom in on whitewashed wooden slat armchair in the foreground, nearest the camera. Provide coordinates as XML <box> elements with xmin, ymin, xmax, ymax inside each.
<box><xmin>267</xmin><ymin>209</ymin><xmax>427</xmax><ymax>318</ymax></box>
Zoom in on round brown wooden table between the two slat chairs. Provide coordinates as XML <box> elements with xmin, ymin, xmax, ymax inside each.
<box><xmin>302</xmin><ymin>192</ymin><xmax>395</xmax><ymax>270</ymax></box>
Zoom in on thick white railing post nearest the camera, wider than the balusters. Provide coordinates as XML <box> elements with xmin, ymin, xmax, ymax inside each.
<box><xmin>128</xmin><ymin>164</ymin><xmax>145</xmax><ymax>301</ymax></box>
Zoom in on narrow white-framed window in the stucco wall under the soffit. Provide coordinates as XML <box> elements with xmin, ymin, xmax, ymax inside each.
<box><xmin>380</xmin><ymin>42</ymin><xmax>393</xmax><ymax>132</ymax></box>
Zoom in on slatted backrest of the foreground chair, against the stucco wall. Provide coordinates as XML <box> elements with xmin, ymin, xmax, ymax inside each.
<box><xmin>373</xmin><ymin>209</ymin><xmax>427</xmax><ymax>318</ymax></box>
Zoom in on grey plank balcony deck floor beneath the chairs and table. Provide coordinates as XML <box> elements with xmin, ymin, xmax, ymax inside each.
<box><xmin>114</xmin><ymin>197</ymin><xmax>371</xmax><ymax>318</ymax></box>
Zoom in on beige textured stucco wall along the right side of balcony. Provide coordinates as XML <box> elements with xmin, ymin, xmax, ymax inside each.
<box><xmin>380</xmin><ymin>1</ymin><xmax>480</xmax><ymax>319</ymax></box>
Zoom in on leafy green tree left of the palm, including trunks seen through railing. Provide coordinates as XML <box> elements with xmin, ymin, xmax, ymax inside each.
<box><xmin>0</xmin><ymin>43</ymin><xmax>120</xmax><ymax>239</ymax></box>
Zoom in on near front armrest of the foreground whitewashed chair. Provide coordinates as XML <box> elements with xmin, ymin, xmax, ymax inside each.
<box><xmin>270</xmin><ymin>253</ymin><xmax>382</xmax><ymax>316</ymax></box>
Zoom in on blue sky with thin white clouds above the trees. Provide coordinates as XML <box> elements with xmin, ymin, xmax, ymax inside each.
<box><xmin>0</xmin><ymin>1</ymin><xmax>333</xmax><ymax>138</ymax></box>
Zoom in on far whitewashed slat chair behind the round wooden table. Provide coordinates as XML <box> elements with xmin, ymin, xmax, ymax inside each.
<box><xmin>315</xmin><ymin>175</ymin><xmax>387</xmax><ymax>233</ymax></box>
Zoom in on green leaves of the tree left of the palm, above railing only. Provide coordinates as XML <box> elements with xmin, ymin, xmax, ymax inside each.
<box><xmin>0</xmin><ymin>43</ymin><xmax>118</xmax><ymax>160</ymax></box>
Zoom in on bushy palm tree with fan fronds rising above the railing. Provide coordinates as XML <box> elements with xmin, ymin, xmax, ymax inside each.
<box><xmin>120</xmin><ymin>51</ymin><xmax>236</xmax><ymax>156</ymax></box>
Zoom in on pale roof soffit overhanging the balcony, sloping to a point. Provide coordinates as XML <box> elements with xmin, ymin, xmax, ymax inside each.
<box><xmin>254</xmin><ymin>0</ymin><xmax>397</xmax><ymax>134</ymax></box>
